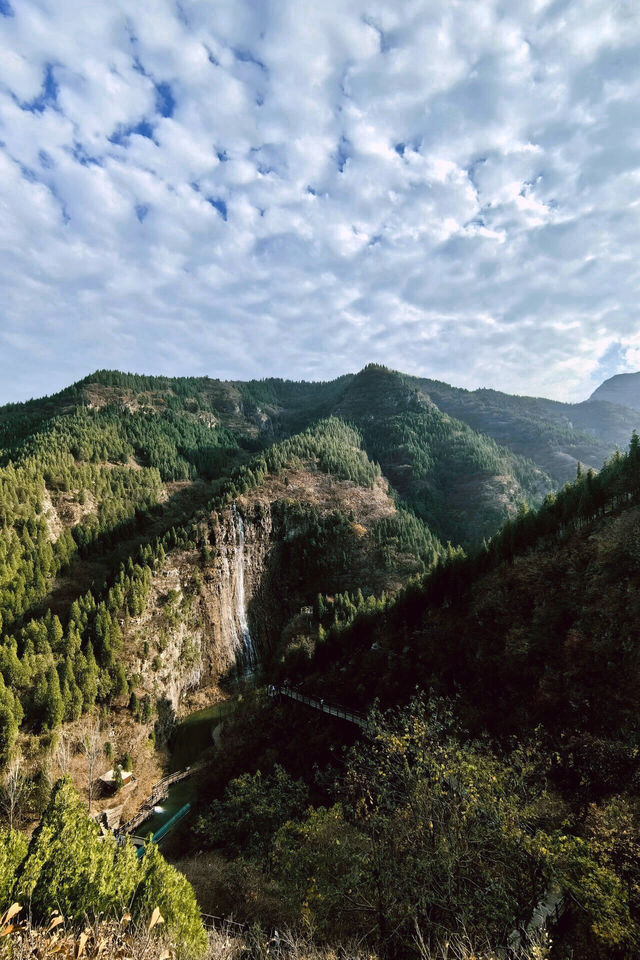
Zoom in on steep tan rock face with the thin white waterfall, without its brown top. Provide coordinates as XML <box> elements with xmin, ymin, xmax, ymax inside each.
<box><xmin>126</xmin><ymin>504</ymin><xmax>288</xmax><ymax>710</ymax></box>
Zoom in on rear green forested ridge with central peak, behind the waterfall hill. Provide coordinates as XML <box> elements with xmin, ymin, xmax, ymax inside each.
<box><xmin>0</xmin><ymin>366</ymin><xmax>552</xmax><ymax>542</ymax></box>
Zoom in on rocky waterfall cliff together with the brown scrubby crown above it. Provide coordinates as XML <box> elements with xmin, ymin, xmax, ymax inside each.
<box><xmin>125</xmin><ymin>471</ymin><xmax>404</xmax><ymax>711</ymax></box>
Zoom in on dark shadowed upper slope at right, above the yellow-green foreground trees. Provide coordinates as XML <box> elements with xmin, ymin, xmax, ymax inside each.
<box><xmin>298</xmin><ymin>438</ymin><xmax>640</xmax><ymax>743</ymax></box>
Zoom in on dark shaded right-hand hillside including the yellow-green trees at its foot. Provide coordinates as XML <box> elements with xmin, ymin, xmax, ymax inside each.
<box><xmin>180</xmin><ymin>435</ymin><xmax>640</xmax><ymax>960</ymax></box>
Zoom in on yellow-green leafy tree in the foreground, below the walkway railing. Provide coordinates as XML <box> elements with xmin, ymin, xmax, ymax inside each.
<box><xmin>298</xmin><ymin>701</ymin><xmax>545</xmax><ymax>954</ymax></box>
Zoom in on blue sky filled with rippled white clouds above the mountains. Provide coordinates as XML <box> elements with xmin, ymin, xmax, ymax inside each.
<box><xmin>0</xmin><ymin>0</ymin><xmax>640</xmax><ymax>402</ymax></box>
